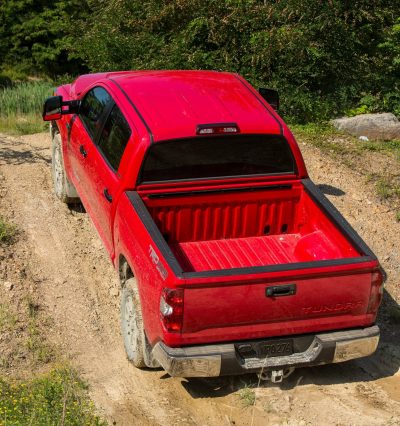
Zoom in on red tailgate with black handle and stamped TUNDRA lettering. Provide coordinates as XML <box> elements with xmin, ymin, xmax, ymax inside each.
<box><xmin>183</xmin><ymin>272</ymin><xmax>371</xmax><ymax>340</ymax></box>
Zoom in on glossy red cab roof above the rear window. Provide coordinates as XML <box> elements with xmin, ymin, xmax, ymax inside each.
<box><xmin>73</xmin><ymin>71</ymin><xmax>282</xmax><ymax>142</ymax></box>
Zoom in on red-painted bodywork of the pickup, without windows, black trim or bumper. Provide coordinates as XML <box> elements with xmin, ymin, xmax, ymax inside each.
<box><xmin>47</xmin><ymin>71</ymin><xmax>381</xmax><ymax>352</ymax></box>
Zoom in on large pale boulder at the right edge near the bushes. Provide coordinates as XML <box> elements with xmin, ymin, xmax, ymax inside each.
<box><xmin>332</xmin><ymin>113</ymin><xmax>400</xmax><ymax>140</ymax></box>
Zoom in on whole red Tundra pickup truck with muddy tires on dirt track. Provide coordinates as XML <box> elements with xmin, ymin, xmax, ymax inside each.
<box><xmin>43</xmin><ymin>71</ymin><xmax>383</xmax><ymax>382</ymax></box>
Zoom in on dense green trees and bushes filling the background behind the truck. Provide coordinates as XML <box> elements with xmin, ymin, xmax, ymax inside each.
<box><xmin>0</xmin><ymin>0</ymin><xmax>400</xmax><ymax>123</ymax></box>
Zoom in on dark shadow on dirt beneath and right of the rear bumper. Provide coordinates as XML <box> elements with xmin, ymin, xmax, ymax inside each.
<box><xmin>182</xmin><ymin>290</ymin><xmax>400</xmax><ymax>398</ymax></box>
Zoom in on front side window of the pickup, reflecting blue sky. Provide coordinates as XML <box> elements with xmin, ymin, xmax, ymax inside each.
<box><xmin>79</xmin><ymin>87</ymin><xmax>112</xmax><ymax>138</ymax></box>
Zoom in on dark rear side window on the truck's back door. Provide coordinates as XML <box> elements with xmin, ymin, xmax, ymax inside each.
<box><xmin>99</xmin><ymin>105</ymin><xmax>131</xmax><ymax>170</ymax></box>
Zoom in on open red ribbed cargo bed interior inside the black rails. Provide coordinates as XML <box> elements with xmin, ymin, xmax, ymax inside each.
<box><xmin>140</xmin><ymin>182</ymin><xmax>360</xmax><ymax>272</ymax></box>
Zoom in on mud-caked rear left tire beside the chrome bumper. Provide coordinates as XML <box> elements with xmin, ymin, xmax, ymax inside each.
<box><xmin>120</xmin><ymin>278</ymin><xmax>147</xmax><ymax>368</ymax></box>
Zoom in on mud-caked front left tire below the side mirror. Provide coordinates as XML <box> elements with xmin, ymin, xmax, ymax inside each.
<box><xmin>51</xmin><ymin>133</ymin><xmax>79</xmax><ymax>204</ymax></box>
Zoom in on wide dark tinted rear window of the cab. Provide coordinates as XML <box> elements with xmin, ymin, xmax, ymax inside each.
<box><xmin>139</xmin><ymin>135</ymin><xmax>296</xmax><ymax>183</ymax></box>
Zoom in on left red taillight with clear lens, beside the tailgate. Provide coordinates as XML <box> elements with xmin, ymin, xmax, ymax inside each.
<box><xmin>160</xmin><ymin>288</ymin><xmax>183</xmax><ymax>333</ymax></box>
